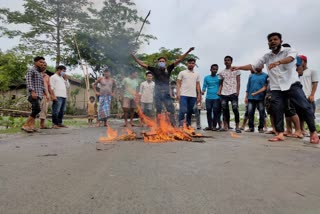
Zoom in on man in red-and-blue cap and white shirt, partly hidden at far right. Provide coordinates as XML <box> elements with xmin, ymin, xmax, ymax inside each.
<box><xmin>296</xmin><ymin>55</ymin><xmax>319</xmax><ymax>132</ymax></box>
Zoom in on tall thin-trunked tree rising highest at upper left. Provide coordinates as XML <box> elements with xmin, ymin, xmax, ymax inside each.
<box><xmin>0</xmin><ymin>0</ymin><xmax>89</xmax><ymax>65</ymax></box>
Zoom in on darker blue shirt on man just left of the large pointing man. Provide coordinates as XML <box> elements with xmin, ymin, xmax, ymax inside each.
<box><xmin>247</xmin><ymin>72</ymin><xmax>268</xmax><ymax>100</ymax></box>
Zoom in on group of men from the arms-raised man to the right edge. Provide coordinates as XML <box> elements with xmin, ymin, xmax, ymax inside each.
<box><xmin>132</xmin><ymin>33</ymin><xmax>319</xmax><ymax>144</ymax></box>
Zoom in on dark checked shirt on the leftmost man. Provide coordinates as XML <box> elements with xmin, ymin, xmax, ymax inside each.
<box><xmin>26</xmin><ymin>67</ymin><xmax>45</xmax><ymax>98</ymax></box>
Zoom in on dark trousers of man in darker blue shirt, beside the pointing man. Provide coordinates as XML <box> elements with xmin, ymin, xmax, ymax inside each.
<box><xmin>248</xmin><ymin>100</ymin><xmax>265</xmax><ymax>129</ymax></box>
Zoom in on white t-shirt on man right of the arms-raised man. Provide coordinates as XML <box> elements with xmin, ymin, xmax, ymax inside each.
<box><xmin>178</xmin><ymin>70</ymin><xmax>200</xmax><ymax>97</ymax></box>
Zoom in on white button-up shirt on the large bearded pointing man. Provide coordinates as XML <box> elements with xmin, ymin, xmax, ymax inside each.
<box><xmin>252</xmin><ymin>47</ymin><xmax>299</xmax><ymax>91</ymax></box>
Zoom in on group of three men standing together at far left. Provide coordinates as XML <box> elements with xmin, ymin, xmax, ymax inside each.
<box><xmin>21</xmin><ymin>56</ymin><xmax>70</xmax><ymax>133</ymax></box>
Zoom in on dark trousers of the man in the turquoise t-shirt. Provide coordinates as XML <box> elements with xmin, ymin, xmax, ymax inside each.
<box><xmin>206</xmin><ymin>99</ymin><xmax>221</xmax><ymax>129</ymax></box>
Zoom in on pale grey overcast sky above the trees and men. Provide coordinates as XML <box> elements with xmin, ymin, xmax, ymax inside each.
<box><xmin>0</xmin><ymin>0</ymin><xmax>320</xmax><ymax>101</ymax></box>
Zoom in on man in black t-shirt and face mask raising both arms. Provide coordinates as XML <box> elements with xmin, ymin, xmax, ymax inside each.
<box><xmin>131</xmin><ymin>47</ymin><xmax>194</xmax><ymax>126</ymax></box>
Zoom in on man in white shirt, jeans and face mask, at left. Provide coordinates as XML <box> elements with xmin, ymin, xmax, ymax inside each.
<box><xmin>50</xmin><ymin>65</ymin><xmax>70</xmax><ymax>129</ymax></box>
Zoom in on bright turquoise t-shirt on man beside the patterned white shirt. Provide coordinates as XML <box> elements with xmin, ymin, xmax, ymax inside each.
<box><xmin>202</xmin><ymin>75</ymin><xmax>220</xmax><ymax>99</ymax></box>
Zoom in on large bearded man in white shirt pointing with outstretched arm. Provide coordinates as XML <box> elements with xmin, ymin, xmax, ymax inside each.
<box><xmin>232</xmin><ymin>33</ymin><xmax>319</xmax><ymax>144</ymax></box>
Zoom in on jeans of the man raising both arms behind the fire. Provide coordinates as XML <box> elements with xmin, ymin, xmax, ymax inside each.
<box><xmin>154</xmin><ymin>88</ymin><xmax>176</xmax><ymax>126</ymax></box>
